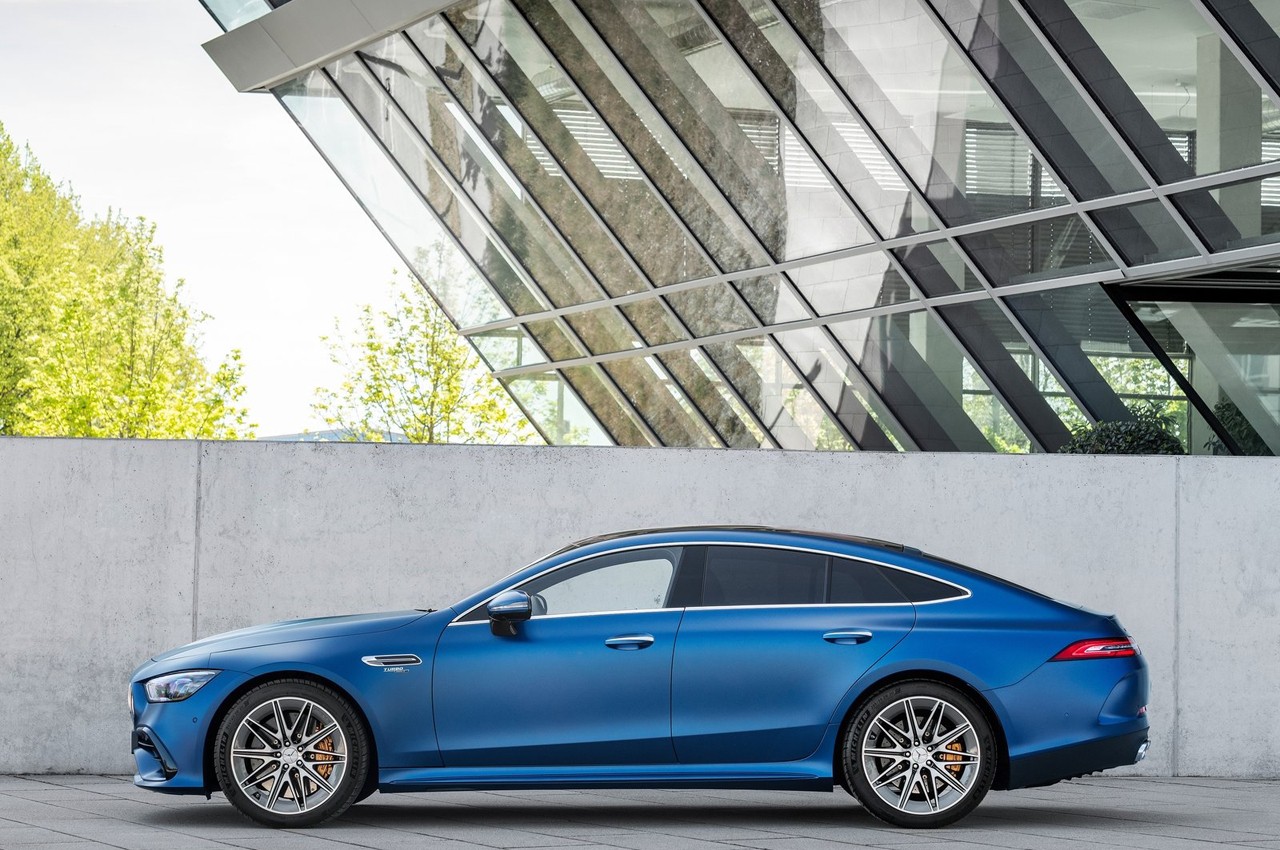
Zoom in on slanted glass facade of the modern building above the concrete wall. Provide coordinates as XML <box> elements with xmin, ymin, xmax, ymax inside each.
<box><xmin>205</xmin><ymin>0</ymin><xmax>1280</xmax><ymax>454</ymax></box>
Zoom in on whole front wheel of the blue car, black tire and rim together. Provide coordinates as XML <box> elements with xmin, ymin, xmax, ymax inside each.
<box><xmin>214</xmin><ymin>678</ymin><xmax>376</xmax><ymax>828</ymax></box>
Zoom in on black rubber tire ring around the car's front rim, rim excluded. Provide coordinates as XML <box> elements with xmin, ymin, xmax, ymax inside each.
<box><xmin>212</xmin><ymin>678</ymin><xmax>370</xmax><ymax>828</ymax></box>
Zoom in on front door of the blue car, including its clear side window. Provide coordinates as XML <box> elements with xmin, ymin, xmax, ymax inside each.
<box><xmin>433</xmin><ymin>547</ymin><xmax>682</xmax><ymax>767</ymax></box>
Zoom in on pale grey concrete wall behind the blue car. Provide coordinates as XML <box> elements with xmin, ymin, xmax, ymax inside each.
<box><xmin>0</xmin><ymin>439</ymin><xmax>1280</xmax><ymax>777</ymax></box>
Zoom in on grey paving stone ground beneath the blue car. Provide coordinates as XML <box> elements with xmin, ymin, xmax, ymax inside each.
<box><xmin>0</xmin><ymin>776</ymin><xmax>1280</xmax><ymax>850</ymax></box>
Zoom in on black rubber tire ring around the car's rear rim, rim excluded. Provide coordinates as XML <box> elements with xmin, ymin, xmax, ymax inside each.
<box><xmin>841</xmin><ymin>680</ymin><xmax>998</xmax><ymax>830</ymax></box>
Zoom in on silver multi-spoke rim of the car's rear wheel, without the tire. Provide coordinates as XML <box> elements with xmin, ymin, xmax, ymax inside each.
<box><xmin>859</xmin><ymin>696</ymin><xmax>982</xmax><ymax>814</ymax></box>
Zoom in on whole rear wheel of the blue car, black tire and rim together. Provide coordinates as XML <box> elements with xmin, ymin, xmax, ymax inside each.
<box><xmin>841</xmin><ymin>680</ymin><xmax>998</xmax><ymax>830</ymax></box>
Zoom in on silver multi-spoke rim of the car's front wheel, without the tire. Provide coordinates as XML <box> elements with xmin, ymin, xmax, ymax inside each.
<box><xmin>230</xmin><ymin>696</ymin><xmax>348</xmax><ymax>815</ymax></box>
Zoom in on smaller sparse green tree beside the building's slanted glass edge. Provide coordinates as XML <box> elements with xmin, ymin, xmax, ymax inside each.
<box><xmin>314</xmin><ymin>256</ymin><xmax>541</xmax><ymax>443</ymax></box>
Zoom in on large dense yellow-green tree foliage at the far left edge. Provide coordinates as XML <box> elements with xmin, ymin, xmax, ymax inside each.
<box><xmin>0</xmin><ymin>125</ymin><xmax>251</xmax><ymax>438</ymax></box>
